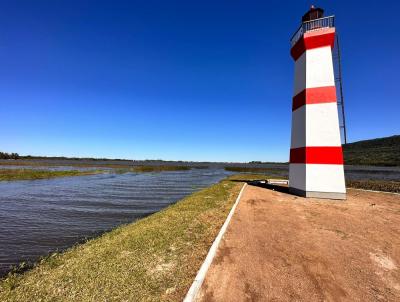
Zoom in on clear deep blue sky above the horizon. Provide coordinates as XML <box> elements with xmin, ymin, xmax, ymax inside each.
<box><xmin>0</xmin><ymin>0</ymin><xmax>400</xmax><ymax>161</ymax></box>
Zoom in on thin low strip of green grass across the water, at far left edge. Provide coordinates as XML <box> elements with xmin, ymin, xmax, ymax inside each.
<box><xmin>0</xmin><ymin>169</ymin><xmax>104</xmax><ymax>181</ymax></box>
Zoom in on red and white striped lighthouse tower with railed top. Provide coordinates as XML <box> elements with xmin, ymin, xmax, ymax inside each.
<box><xmin>289</xmin><ymin>6</ymin><xmax>346</xmax><ymax>199</ymax></box>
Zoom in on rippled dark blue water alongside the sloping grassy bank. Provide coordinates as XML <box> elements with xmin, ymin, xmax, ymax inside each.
<box><xmin>0</xmin><ymin>169</ymin><xmax>231</xmax><ymax>275</ymax></box>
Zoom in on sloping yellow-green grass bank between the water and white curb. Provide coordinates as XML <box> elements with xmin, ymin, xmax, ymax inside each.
<box><xmin>0</xmin><ymin>175</ymin><xmax>244</xmax><ymax>301</ymax></box>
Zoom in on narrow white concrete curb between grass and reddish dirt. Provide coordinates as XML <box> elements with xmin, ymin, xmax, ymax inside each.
<box><xmin>183</xmin><ymin>183</ymin><xmax>247</xmax><ymax>302</ymax></box>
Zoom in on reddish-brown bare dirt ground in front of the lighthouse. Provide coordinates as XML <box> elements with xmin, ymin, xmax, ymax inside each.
<box><xmin>198</xmin><ymin>186</ymin><xmax>400</xmax><ymax>302</ymax></box>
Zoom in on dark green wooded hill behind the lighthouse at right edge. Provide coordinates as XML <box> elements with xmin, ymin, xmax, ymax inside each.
<box><xmin>343</xmin><ymin>135</ymin><xmax>400</xmax><ymax>166</ymax></box>
